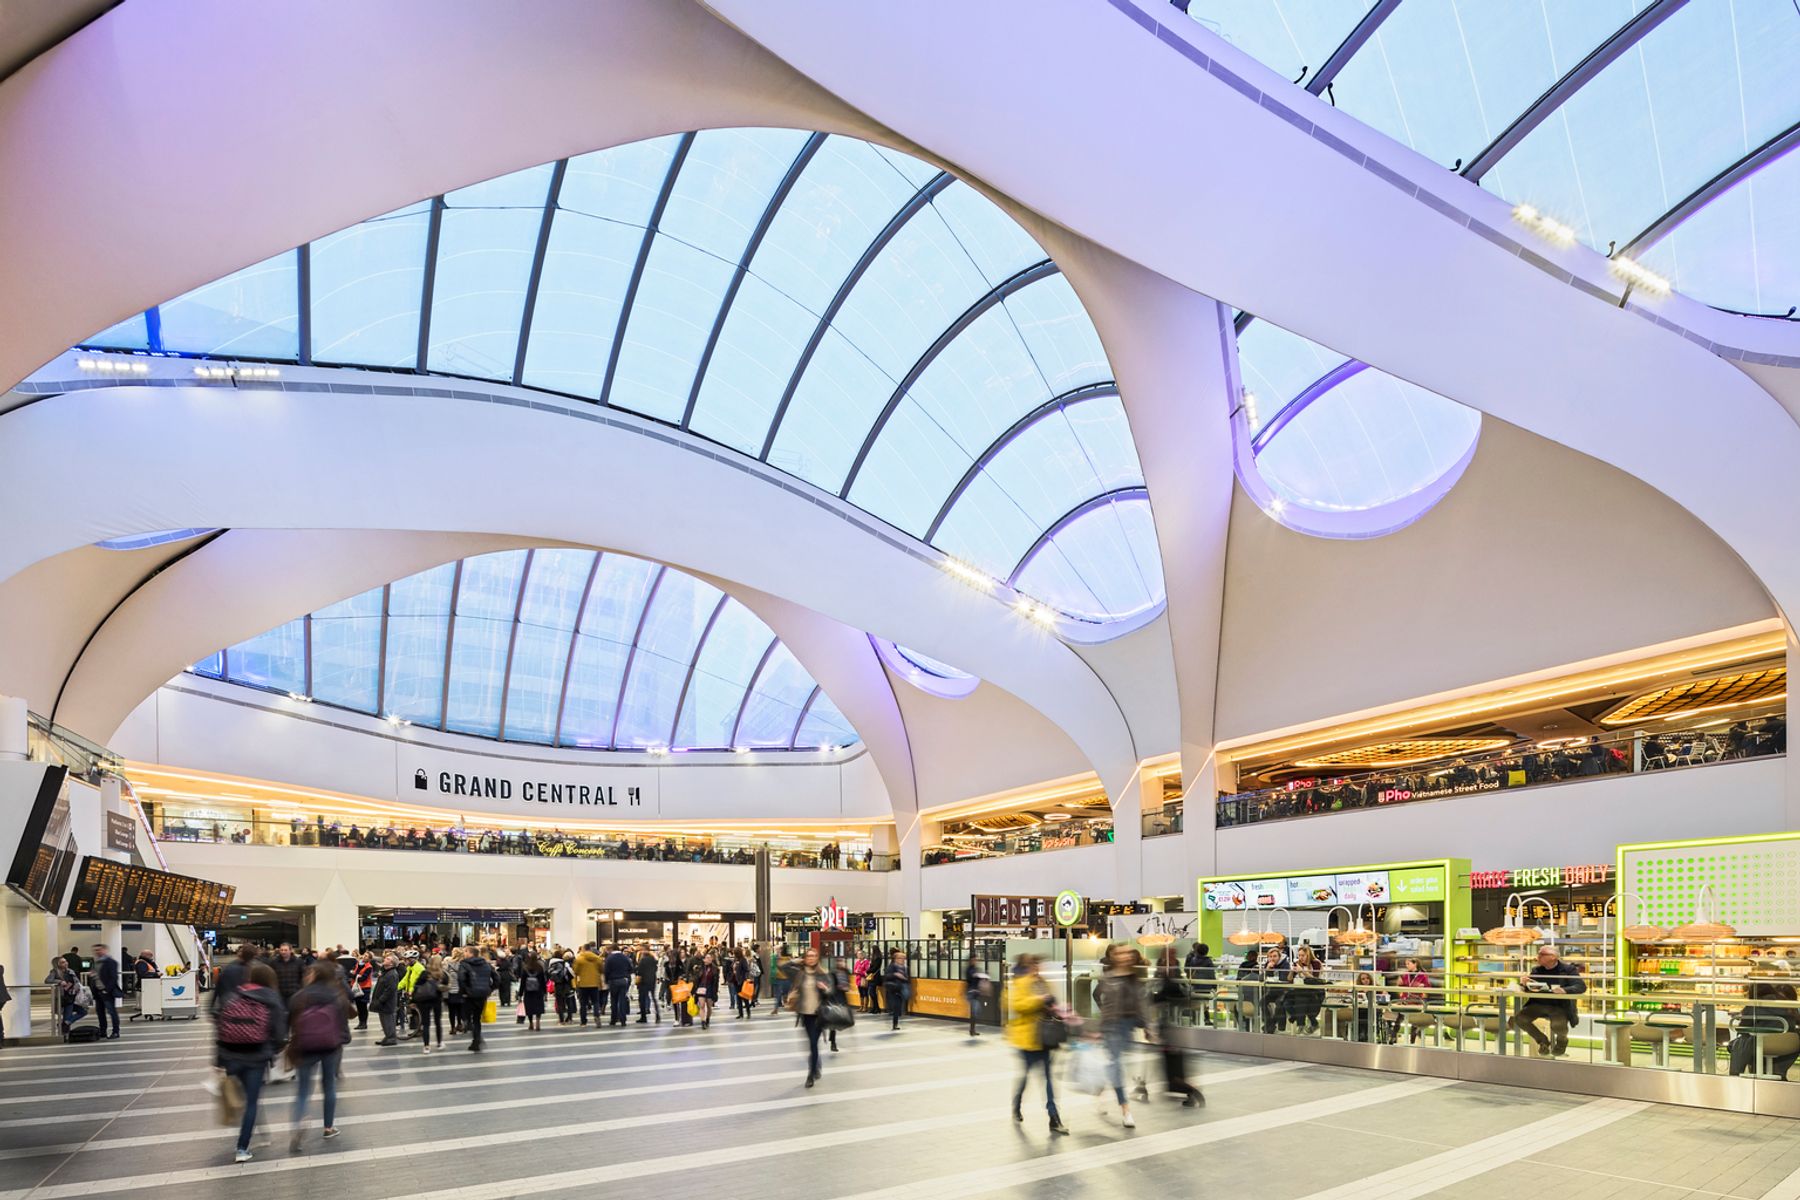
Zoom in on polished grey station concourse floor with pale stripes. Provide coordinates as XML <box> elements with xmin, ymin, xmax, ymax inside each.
<box><xmin>0</xmin><ymin>1015</ymin><xmax>1800</xmax><ymax>1200</ymax></box>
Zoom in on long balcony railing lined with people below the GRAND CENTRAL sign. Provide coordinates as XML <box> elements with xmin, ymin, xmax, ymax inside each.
<box><xmin>151</xmin><ymin>811</ymin><xmax>900</xmax><ymax>871</ymax></box>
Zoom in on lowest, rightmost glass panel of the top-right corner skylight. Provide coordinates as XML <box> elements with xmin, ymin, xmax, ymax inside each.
<box><xmin>1634</xmin><ymin>141</ymin><xmax>1800</xmax><ymax>317</ymax></box>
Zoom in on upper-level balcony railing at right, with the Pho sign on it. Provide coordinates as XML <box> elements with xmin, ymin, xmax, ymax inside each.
<box><xmin>1219</xmin><ymin>718</ymin><xmax>1787</xmax><ymax>826</ymax></box>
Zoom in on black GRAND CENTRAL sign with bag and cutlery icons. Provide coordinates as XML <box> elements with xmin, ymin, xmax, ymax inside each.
<box><xmin>394</xmin><ymin>747</ymin><xmax>661</xmax><ymax>817</ymax></box>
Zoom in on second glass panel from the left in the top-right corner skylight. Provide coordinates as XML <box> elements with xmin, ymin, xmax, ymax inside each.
<box><xmin>1332</xmin><ymin>0</ymin><xmax>1642</xmax><ymax>167</ymax></box>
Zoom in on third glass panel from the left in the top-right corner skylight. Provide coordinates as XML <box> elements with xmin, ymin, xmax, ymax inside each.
<box><xmin>1483</xmin><ymin>0</ymin><xmax>1800</xmax><ymax>250</ymax></box>
